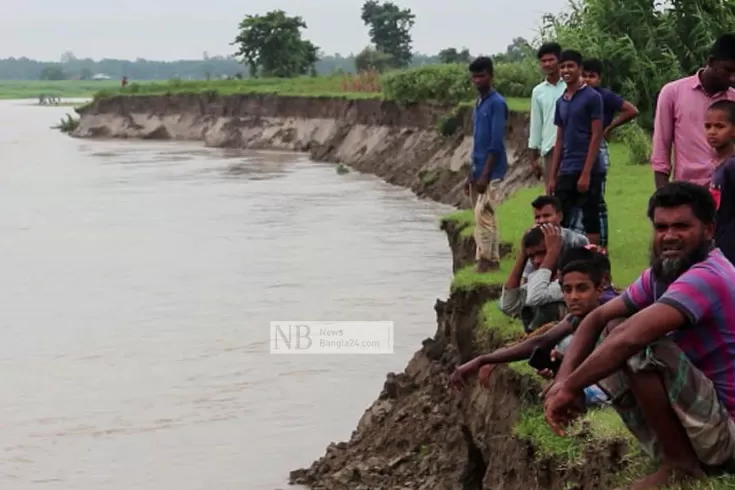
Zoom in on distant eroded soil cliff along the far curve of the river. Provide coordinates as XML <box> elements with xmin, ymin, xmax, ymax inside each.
<box><xmin>72</xmin><ymin>94</ymin><xmax>538</xmax><ymax>207</ymax></box>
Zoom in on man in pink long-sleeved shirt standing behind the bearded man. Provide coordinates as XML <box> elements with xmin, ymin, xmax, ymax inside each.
<box><xmin>651</xmin><ymin>34</ymin><xmax>735</xmax><ymax>188</ymax></box>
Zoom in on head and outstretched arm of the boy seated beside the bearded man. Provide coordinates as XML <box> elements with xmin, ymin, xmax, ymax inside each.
<box><xmin>449</xmin><ymin>250</ymin><xmax>609</xmax><ymax>398</ymax></box>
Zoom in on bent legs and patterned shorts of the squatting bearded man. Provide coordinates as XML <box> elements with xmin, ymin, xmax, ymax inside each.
<box><xmin>599</xmin><ymin>339</ymin><xmax>735</xmax><ymax>489</ymax></box>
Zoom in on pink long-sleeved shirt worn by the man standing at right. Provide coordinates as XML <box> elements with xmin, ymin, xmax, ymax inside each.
<box><xmin>651</xmin><ymin>74</ymin><xmax>735</xmax><ymax>185</ymax></box>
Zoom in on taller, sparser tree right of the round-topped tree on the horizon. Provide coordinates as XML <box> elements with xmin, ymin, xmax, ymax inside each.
<box><xmin>361</xmin><ymin>0</ymin><xmax>416</xmax><ymax>68</ymax></box>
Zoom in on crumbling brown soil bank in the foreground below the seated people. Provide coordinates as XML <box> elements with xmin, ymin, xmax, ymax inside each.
<box><xmin>290</xmin><ymin>221</ymin><xmax>631</xmax><ymax>490</ymax></box>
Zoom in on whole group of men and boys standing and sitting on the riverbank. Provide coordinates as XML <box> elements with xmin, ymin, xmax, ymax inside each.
<box><xmin>458</xmin><ymin>34</ymin><xmax>735</xmax><ymax>490</ymax></box>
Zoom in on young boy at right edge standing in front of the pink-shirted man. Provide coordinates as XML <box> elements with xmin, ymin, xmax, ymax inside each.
<box><xmin>704</xmin><ymin>100</ymin><xmax>735</xmax><ymax>263</ymax></box>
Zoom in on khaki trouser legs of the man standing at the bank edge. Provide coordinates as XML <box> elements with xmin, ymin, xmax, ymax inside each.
<box><xmin>475</xmin><ymin>180</ymin><xmax>500</xmax><ymax>272</ymax></box>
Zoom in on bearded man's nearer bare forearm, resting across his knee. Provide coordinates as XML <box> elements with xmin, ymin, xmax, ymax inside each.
<box><xmin>564</xmin><ymin>303</ymin><xmax>688</xmax><ymax>392</ymax></box>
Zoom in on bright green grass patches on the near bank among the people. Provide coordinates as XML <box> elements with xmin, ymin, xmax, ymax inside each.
<box><xmin>443</xmin><ymin>144</ymin><xmax>735</xmax><ymax>490</ymax></box>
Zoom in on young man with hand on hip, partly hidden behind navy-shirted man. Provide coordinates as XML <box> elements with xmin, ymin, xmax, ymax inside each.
<box><xmin>578</xmin><ymin>58</ymin><xmax>638</xmax><ymax>248</ymax></box>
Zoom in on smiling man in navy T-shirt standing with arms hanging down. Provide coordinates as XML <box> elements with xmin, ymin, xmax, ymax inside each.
<box><xmin>546</xmin><ymin>50</ymin><xmax>605</xmax><ymax>245</ymax></box>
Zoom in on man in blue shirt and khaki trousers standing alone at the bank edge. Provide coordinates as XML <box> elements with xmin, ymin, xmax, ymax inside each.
<box><xmin>465</xmin><ymin>56</ymin><xmax>508</xmax><ymax>272</ymax></box>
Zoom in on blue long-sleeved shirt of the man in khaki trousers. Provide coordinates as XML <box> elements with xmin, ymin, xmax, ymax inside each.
<box><xmin>471</xmin><ymin>90</ymin><xmax>508</xmax><ymax>181</ymax></box>
